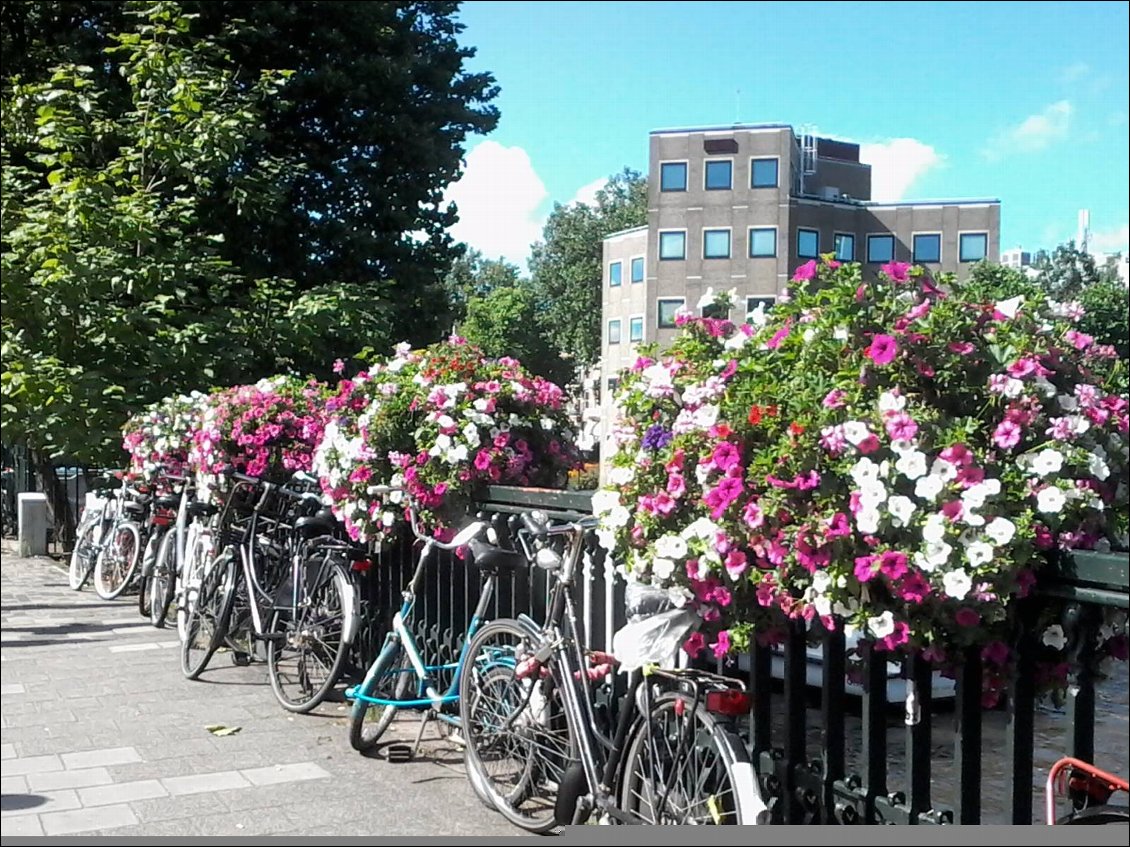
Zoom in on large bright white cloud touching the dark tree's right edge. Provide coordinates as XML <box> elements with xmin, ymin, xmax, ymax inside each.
<box><xmin>444</xmin><ymin>141</ymin><xmax>549</xmax><ymax>267</ymax></box>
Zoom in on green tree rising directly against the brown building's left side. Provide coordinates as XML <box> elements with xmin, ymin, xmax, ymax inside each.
<box><xmin>530</xmin><ymin>168</ymin><xmax>647</xmax><ymax>377</ymax></box>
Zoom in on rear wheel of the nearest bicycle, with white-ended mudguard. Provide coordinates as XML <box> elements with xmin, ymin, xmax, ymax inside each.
<box><xmin>620</xmin><ymin>692</ymin><xmax>759</xmax><ymax>826</ymax></box>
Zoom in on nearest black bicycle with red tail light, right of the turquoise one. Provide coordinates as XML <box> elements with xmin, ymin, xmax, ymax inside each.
<box><xmin>460</xmin><ymin>514</ymin><xmax>768</xmax><ymax>832</ymax></box>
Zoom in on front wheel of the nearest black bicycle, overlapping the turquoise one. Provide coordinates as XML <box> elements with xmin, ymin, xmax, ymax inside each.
<box><xmin>459</xmin><ymin>620</ymin><xmax>575</xmax><ymax>832</ymax></box>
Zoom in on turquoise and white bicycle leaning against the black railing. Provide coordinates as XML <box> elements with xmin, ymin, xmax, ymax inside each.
<box><xmin>346</xmin><ymin>487</ymin><xmax>528</xmax><ymax>758</ymax></box>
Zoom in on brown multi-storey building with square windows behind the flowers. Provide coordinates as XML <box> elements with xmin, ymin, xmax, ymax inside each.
<box><xmin>600</xmin><ymin>124</ymin><xmax>1000</xmax><ymax>467</ymax></box>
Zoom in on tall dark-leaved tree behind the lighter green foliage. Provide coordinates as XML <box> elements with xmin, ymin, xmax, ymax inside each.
<box><xmin>0</xmin><ymin>0</ymin><xmax>498</xmax><ymax>346</ymax></box>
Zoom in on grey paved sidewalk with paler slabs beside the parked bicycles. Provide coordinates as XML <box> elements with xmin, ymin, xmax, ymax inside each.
<box><xmin>0</xmin><ymin>550</ymin><xmax>523</xmax><ymax>837</ymax></box>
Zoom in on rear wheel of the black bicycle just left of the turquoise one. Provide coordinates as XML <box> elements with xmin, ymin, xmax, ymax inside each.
<box><xmin>267</xmin><ymin>564</ymin><xmax>353</xmax><ymax>713</ymax></box>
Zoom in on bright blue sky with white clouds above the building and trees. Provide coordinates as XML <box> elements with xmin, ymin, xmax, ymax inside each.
<box><xmin>440</xmin><ymin>0</ymin><xmax>1130</xmax><ymax>263</ymax></box>
